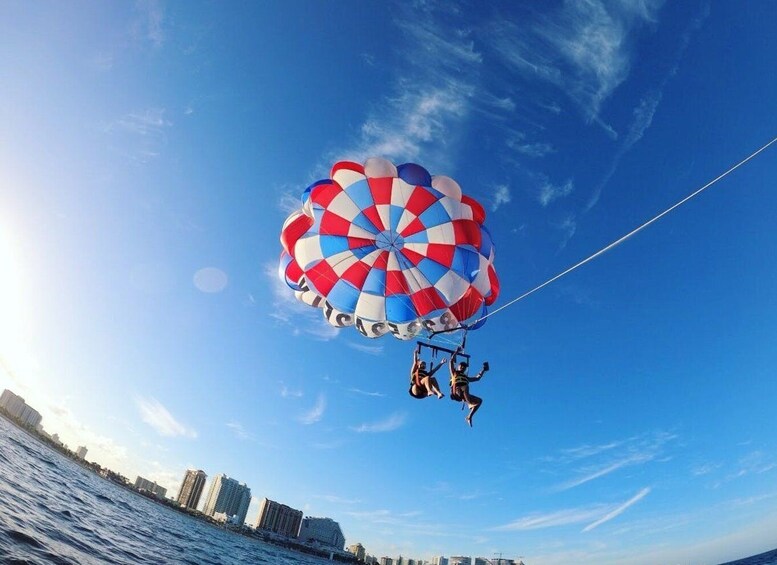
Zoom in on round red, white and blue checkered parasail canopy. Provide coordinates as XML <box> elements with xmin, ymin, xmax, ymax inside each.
<box><xmin>279</xmin><ymin>158</ymin><xmax>499</xmax><ymax>339</ymax></box>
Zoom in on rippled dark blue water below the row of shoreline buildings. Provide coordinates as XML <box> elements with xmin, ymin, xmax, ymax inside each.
<box><xmin>0</xmin><ymin>417</ymin><xmax>334</xmax><ymax>565</ymax></box>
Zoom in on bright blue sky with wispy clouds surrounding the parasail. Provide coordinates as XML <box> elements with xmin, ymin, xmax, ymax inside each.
<box><xmin>0</xmin><ymin>0</ymin><xmax>777</xmax><ymax>565</ymax></box>
